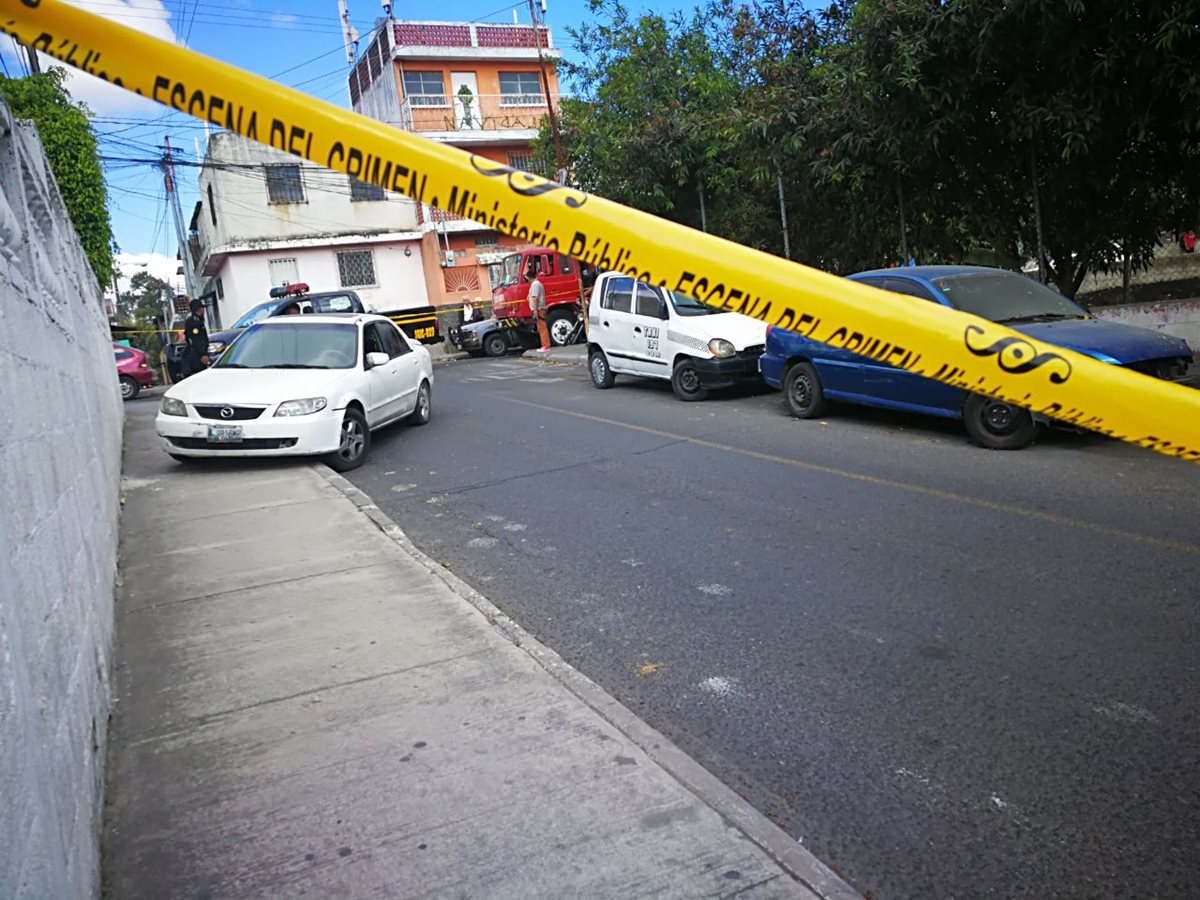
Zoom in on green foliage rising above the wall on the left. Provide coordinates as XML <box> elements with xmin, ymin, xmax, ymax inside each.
<box><xmin>0</xmin><ymin>67</ymin><xmax>113</xmax><ymax>284</ymax></box>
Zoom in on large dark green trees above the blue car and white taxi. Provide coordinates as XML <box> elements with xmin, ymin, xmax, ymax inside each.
<box><xmin>540</xmin><ymin>0</ymin><xmax>1200</xmax><ymax>295</ymax></box>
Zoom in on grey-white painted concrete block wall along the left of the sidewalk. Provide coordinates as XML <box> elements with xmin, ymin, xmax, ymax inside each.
<box><xmin>0</xmin><ymin>102</ymin><xmax>122</xmax><ymax>900</ymax></box>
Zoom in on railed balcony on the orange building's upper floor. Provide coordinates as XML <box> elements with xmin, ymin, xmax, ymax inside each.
<box><xmin>400</xmin><ymin>94</ymin><xmax>558</xmax><ymax>143</ymax></box>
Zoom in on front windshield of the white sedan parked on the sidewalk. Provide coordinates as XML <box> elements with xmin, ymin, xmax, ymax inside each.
<box><xmin>215</xmin><ymin>317</ymin><xmax>359</xmax><ymax>368</ymax></box>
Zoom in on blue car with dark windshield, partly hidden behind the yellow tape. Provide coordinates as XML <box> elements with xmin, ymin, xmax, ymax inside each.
<box><xmin>761</xmin><ymin>265</ymin><xmax>1192</xmax><ymax>450</ymax></box>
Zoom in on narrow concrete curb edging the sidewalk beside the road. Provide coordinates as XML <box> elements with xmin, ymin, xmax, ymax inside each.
<box><xmin>312</xmin><ymin>465</ymin><xmax>862</xmax><ymax>900</ymax></box>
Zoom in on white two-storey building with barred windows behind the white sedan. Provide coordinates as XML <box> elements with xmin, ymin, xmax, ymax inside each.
<box><xmin>191</xmin><ymin>132</ymin><xmax>430</xmax><ymax>326</ymax></box>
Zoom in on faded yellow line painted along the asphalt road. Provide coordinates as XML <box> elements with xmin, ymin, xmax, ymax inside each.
<box><xmin>496</xmin><ymin>395</ymin><xmax>1200</xmax><ymax>553</ymax></box>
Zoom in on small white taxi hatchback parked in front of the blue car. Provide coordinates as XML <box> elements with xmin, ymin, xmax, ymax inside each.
<box><xmin>588</xmin><ymin>272</ymin><xmax>767</xmax><ymax>401</ymax></box>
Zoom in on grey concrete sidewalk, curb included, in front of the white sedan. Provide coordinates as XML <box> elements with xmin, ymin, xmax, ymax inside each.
<box><xmin>104</xmin><ymin>401</ymin><xmax>852</xmax><ymax>900</ymax></box>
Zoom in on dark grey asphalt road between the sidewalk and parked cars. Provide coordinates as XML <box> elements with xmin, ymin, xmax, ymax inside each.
<box><xmin>354</xmin><ymin>359</ymin><xmax>1200</xmax><ymax>899</ymax></box>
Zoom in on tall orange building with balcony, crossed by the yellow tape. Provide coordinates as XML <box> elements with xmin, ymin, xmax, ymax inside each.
<box><xmin>349</xmin><ymin>22</ymin><xmax>562</xmax><ymax>314</ymax></box>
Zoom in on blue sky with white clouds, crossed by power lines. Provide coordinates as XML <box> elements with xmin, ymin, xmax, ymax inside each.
<box><xmin>0</xmin><ymin>0</ymin><xmax>676</xmax><ymax>289</ymax></box>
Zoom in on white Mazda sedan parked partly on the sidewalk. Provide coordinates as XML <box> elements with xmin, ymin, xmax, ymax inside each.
<box><xmin>155</xmin><ymin>314</ymin><xmax>433</xmax><ymax>472</ymax></box>
